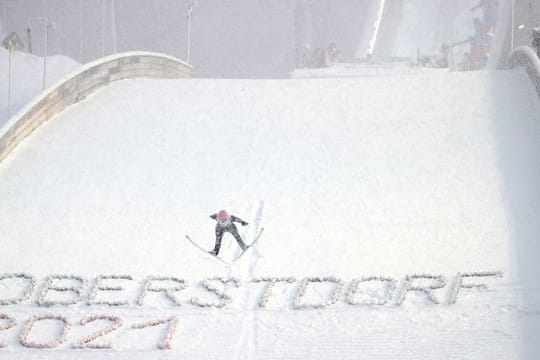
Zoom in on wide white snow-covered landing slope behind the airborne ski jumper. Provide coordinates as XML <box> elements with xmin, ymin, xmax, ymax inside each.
<box><xmin>0</xmin><ymin>71</ymin><xmax>540</xmax><ymax>359</ymax></box>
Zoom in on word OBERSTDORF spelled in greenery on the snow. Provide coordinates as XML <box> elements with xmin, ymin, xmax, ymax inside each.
<box><xmin>0</xmin><ymin>271</ymin><xmax>503</xmax><ymax>310</ymax></box>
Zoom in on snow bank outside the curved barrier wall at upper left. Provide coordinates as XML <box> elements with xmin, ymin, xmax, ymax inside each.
<box><xmin>0</xmin><ymin>47</ymin><xmax>80</xmax><ymax>127</ymax></box>
